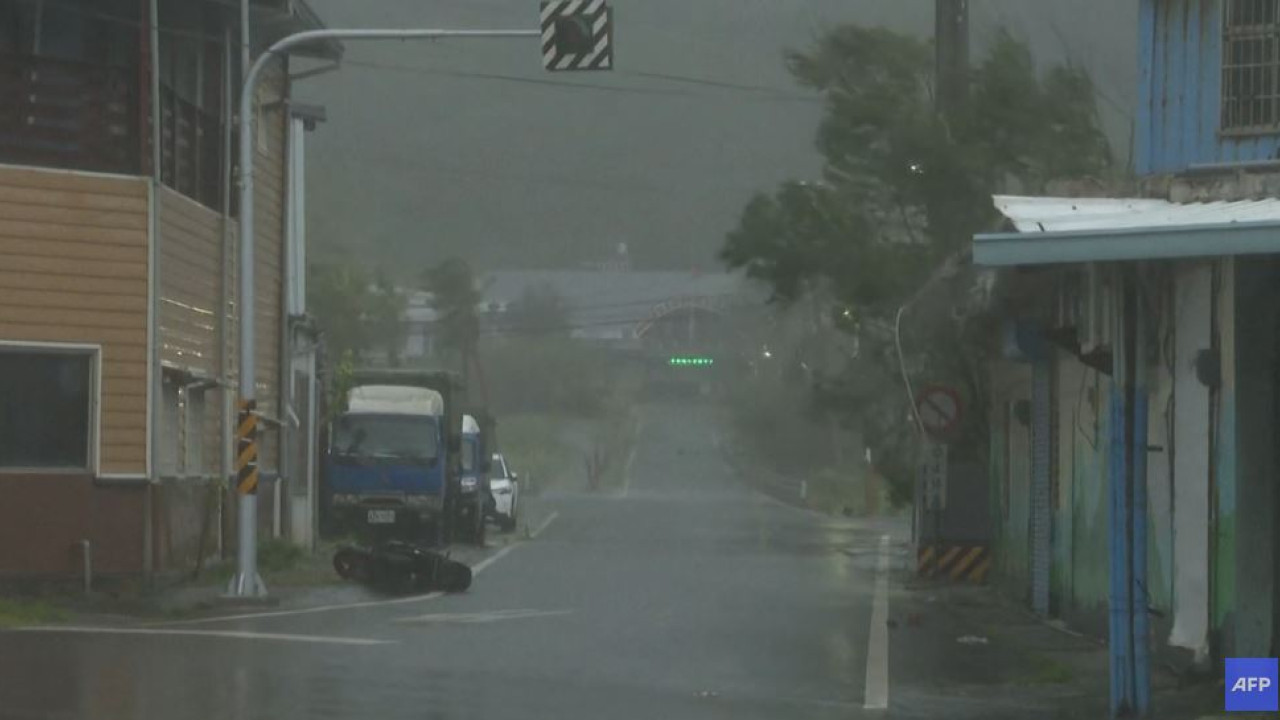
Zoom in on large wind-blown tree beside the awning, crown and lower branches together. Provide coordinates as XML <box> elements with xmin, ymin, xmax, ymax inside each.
<box><xmin>721</xmin><ymin>26</ymin><xmax>1111</xmax><ymax>499</ymax></box>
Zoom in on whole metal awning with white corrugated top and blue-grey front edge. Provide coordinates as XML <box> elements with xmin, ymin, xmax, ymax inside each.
<box><xmin>973</xmin><ymin>195</ymin><xmax>1280</xmax><ymax>266</ymax></box>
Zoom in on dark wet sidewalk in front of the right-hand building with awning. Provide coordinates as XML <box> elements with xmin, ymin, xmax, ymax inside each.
<box><xmin>890</xmin><ymin>571</ymin><xmax>1222</xmax><ymax>720</ymax></box>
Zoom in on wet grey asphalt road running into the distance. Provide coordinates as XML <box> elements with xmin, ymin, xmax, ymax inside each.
<box><xmin>0</xmin><ymin>407</ymin><xmax>906</xmax><ymax>720</ymax></box>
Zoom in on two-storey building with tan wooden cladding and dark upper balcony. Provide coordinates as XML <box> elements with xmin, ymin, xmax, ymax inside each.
<box><xmin>0</xmin><ymin>0</ymin><xmax>340</xmax><ymax>579</ymax></box>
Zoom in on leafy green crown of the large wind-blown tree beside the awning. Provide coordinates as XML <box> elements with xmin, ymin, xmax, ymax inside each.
<box><xmin>721</xmin><ymin>26</ymin><xmax>1110</xmax><ymax>307</ymax></box>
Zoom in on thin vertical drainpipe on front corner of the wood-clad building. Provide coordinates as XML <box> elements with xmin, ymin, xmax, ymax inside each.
<box><xmin>142</xmin><ymin>0</ymin><xmax>163</xmax><ymax>583</ymax></box>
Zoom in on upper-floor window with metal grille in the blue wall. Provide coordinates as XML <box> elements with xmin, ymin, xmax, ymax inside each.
<box><xmin>1222</xmin><ymin>0</ymin><xmax>1280</xmax><ymax>132</ymax></box>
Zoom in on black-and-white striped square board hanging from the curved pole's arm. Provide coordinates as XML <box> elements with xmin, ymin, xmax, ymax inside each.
<box><xmin>541</xmin><ymin>0</ymin><xmax>613</xmax><ymax>70</ymax></box>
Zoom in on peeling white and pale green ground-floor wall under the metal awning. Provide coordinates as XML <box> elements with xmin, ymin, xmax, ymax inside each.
<box><xmin>989</xmin><ymin>259</ymin><xmax>1254</xmax><ymax>659</ymax></box>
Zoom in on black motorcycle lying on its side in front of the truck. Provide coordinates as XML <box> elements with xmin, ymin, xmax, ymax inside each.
<box><xmin>333</xmin><ymin>541</ymin><xmax>471</xmax><ymax>593</ymax></box>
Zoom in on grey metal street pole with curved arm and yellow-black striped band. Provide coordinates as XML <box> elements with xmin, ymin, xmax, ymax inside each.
<box><xmin>227</xmin><ymin>29</ymin><xmax>541</xmax><ymax>597</ymax></box>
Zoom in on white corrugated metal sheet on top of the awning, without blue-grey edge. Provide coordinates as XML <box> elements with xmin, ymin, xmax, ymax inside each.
<box><xmin>995</xmin><ymin>195</ymin><xmax>1280</xmax><ymax>232</ymax></box>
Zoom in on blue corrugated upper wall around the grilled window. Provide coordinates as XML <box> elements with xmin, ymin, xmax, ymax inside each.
<box><xmin>1134</xmin><ymin>0</ymin><xmax>1280</xmax><ymax>174</ymax></box>
